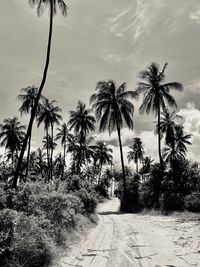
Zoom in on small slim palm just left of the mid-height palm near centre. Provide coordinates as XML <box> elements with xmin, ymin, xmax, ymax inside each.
<box><xmin>55</xmin><ymin>123</ymin><xmax>73</xmax><ymax>176</ymax></box>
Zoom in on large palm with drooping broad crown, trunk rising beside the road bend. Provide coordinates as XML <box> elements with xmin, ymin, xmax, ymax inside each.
<box><xmin>90</xmin><ymin>80</ymin><xmax>135</xmax><ymax>194</ymax></box>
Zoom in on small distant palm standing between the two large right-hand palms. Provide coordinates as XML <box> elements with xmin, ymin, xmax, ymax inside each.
<box><xmin>127</xmin><ymin>137</ymin><xmax>144</xmax><ymax>173</ymax></box>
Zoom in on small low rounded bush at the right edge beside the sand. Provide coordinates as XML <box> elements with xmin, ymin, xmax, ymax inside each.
<box><xmin>184</xmin><ymin>192</ymin><xmax>200</xmax><ymax>212</ymax></box>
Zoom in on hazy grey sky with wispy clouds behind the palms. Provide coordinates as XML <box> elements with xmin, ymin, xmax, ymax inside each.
<box><xmin>0</xmin><ymin>0</ymin><xmax>200</xmax><ymax>168</ymax></box>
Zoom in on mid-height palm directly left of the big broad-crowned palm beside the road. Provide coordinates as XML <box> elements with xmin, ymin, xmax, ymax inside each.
<box><xmin>68</xmin><ymin>101</ymin><xmax>96</xmax><ymax>174</ymax></box>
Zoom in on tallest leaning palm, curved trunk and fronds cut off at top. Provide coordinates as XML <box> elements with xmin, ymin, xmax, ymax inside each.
<box><xmin>13</xmin><ymin>0</ymin><xmax>67</xmax><ymax>187</ymax></box>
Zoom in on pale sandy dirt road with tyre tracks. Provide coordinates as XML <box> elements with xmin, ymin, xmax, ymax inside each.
<box><xmin>57</xmin><ymin>198</ymin><xmax>200</xmax><ymax>267</ymax></box>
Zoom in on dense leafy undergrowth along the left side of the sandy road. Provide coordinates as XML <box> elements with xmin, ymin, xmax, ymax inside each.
<box><xmin>0</xmin><ymin>176</ymin><xmax>101</xmax><ymax>267</ymax></box>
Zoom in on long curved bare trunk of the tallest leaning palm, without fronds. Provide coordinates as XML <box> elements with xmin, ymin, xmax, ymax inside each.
<box><xmin>13</xmin><ymin>0</ymin><xmax>53</xmax><ymax>188</ymax></box>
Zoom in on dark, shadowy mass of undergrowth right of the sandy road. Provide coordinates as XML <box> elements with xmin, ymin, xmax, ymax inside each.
<box><xmin>116</xmin><ymin>159</ymin><xmax>200</xmax><ymax>213</ymax></box>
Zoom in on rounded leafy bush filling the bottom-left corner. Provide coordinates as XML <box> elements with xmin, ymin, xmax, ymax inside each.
<box><xmin>0</xmin><ymin>209</ymin><xmax>53</xmax><ymax>267</ymax></box>
